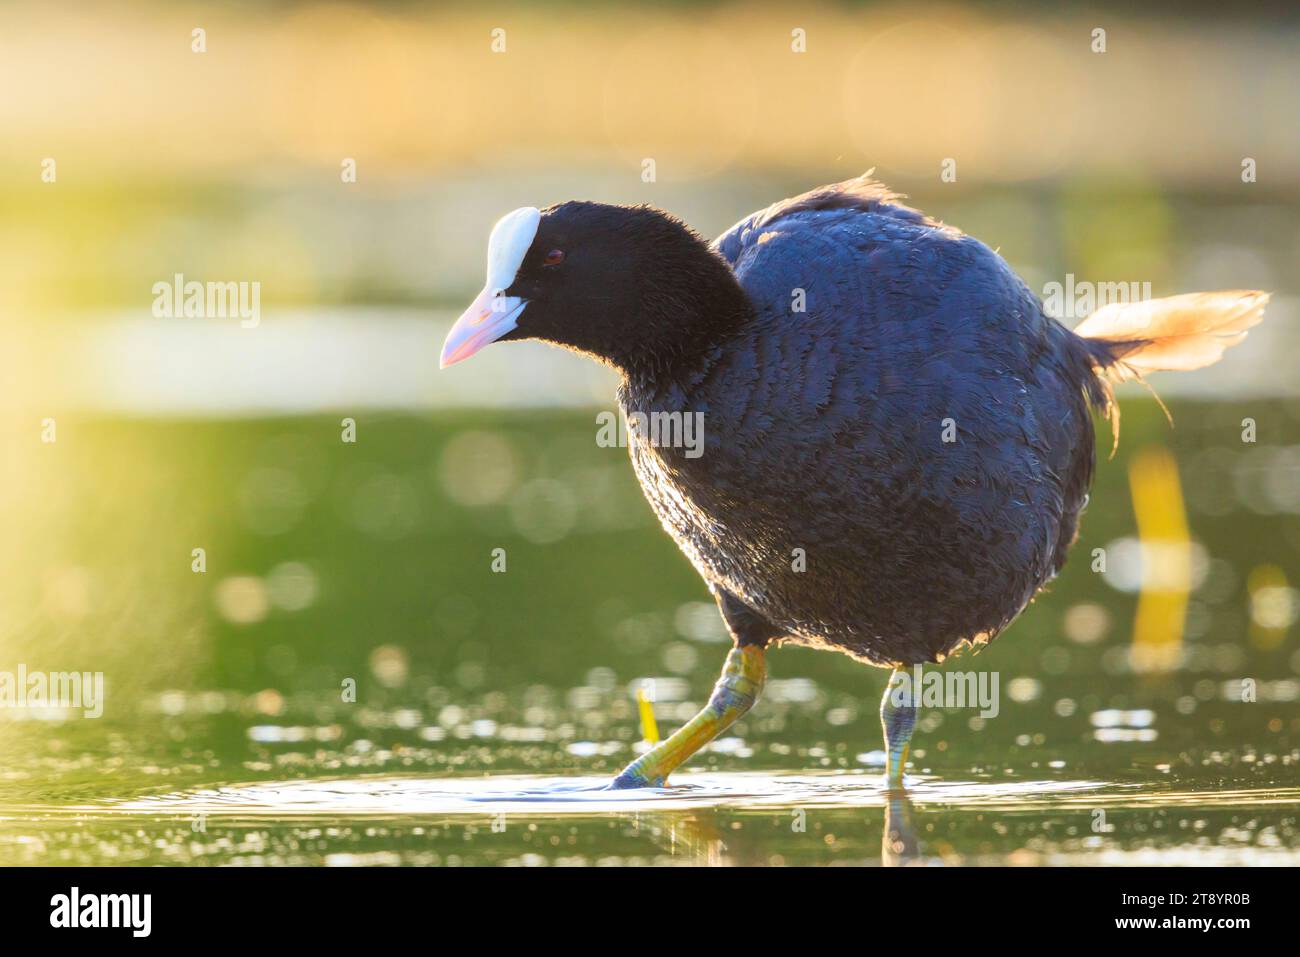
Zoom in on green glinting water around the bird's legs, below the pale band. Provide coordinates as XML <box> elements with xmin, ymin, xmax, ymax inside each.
<box><xmin>0</xmin><ymin>399</ymin><xmax>1300</xmax><ymax>866</ymax></box>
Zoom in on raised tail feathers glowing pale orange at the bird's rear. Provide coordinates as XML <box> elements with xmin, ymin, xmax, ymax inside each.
<box><xmin>1074</xmin><ymin>289</ymin><xmax>1269</xmax><ymax>443</ymax></box>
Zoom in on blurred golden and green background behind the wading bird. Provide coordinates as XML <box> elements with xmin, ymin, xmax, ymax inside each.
<box><xmin>0</xmin><ymin>0</ymin><xmax>1300</xmax><ymax>863</ymax></box>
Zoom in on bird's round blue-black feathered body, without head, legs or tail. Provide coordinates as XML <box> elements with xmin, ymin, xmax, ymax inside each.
<box><xmin>621</xmin><ymin>179</ymin><xmax>1093</xmax><ymax>663</ymax></box>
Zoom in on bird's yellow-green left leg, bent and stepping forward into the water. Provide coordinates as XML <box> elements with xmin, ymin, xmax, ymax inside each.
<box><xmin>610</xmin><ymin>645</ymin><xmax>767</xmax><ymax>788</ymax></box>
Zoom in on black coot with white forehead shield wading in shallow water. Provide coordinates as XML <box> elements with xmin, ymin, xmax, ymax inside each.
<box><xmin>442</xmin><ymin>174</ymin><xmax>1268</xmax><ymax>787</ymax></box>
